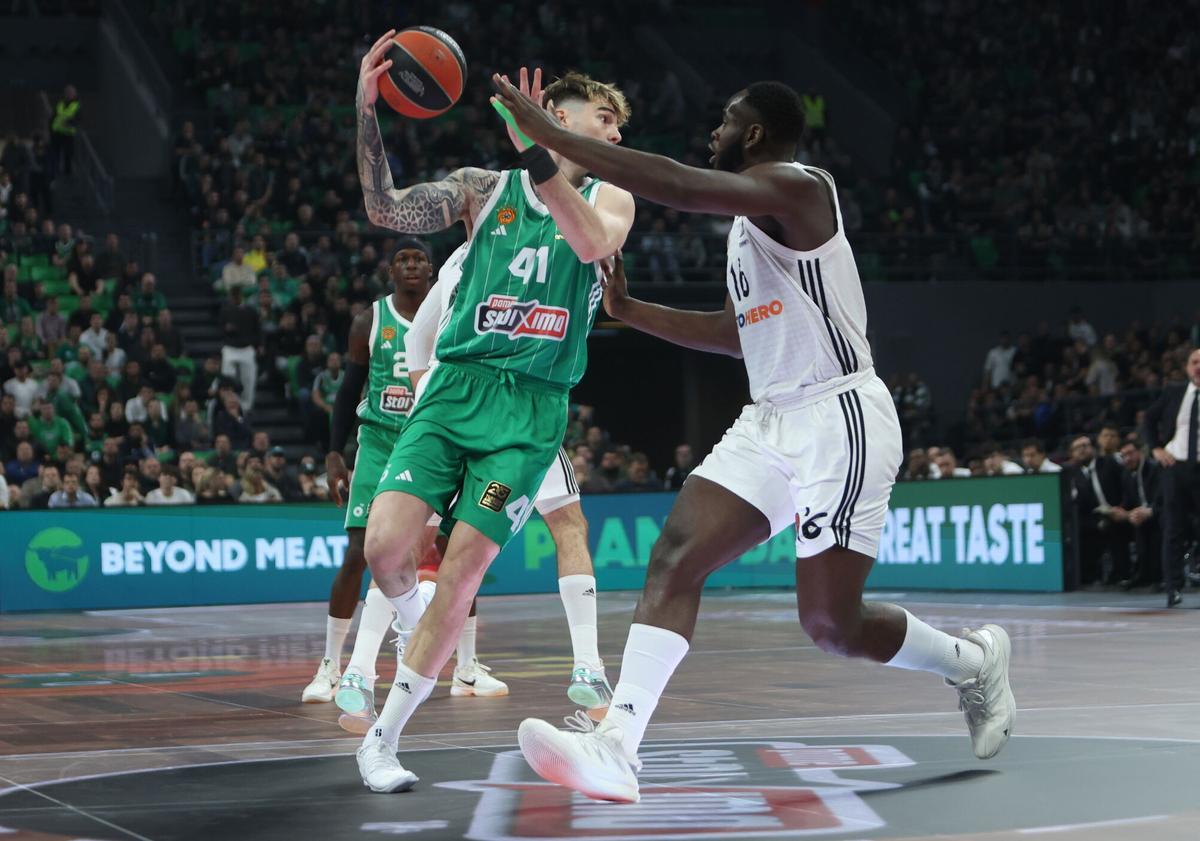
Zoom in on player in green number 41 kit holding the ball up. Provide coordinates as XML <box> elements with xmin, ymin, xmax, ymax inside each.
<box><xmin>356</xmin><ymin>32</ymin><xmax>634</xmax><ymax>792</ymax></box>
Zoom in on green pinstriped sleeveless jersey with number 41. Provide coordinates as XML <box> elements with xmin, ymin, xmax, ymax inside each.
<box><xmin>437</xmin><ymin>169</ymin><xmax>602</xmax><ymax>389</ymax></box>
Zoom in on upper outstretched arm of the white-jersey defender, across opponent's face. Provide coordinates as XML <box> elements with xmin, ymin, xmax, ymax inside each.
<box><xmin>496</xmin><ymin>71</ymin><xmax>821</xmax><ymax>216</ymax></box>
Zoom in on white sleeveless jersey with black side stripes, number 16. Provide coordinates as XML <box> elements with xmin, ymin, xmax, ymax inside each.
<box><xmin>726</xmin><ymin>163</ymin><xmax>875</xmax><ymax>407</ymax></box>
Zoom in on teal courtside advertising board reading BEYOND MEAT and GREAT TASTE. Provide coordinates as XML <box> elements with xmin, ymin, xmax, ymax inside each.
<box><xmin>0</xmin><ymin>476</ymin><xmax>1063</xmax><ymax>611</ymax></box>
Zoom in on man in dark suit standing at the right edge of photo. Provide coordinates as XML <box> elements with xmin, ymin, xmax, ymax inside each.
<box><xmin>1142</xmin><ymin>350</ymin><xmax>1200</xmax><ymax>607</ymax></box>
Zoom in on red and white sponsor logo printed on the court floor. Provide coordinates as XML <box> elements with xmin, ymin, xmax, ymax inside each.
<box><xmin>437</xmin><ymin>740</ymin><xmax>914</xmax><ymax>841</ymax></box>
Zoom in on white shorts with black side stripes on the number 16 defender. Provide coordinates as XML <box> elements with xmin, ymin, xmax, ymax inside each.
<box><xmin>691</xmin><ymin>377</ymin><xmax>904</xmax><ymax>558</ymax></box>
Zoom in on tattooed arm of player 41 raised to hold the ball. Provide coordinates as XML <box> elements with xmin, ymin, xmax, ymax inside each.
<box><xmin>355</xmin><ymin>30</ymin><xmax>499</xmax><ymax>234</ymax></box>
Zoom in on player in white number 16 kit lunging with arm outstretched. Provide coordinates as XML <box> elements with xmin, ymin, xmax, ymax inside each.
<box><xmin>493</xmin><ymin>77</ymin><xmax>1016</xmax><ymax>801</ymax></box>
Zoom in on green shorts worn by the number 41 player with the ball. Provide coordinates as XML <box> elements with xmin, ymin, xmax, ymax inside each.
<box><xmin>376</xmin><ymin>361</ymin><xmax>566</xmax><ymax>548</ymax></box>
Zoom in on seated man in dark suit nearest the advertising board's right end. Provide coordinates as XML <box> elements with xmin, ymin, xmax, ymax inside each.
<box><xmin>1067</xmin><ymin>435</ymin><xmax>1129</xmax><ymax>584</ymax></box>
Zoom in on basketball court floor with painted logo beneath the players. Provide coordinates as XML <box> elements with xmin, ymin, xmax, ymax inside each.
<box><xmin>0</xmin><ymin>591</ymin><xmax>1200</xmax><ymax>841</ymax></box>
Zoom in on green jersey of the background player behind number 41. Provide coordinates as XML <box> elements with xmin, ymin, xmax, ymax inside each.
<box><xmin>358</xmin><ymin>294</ymin><xmax>413</xmax><ymax>432</ymax></box>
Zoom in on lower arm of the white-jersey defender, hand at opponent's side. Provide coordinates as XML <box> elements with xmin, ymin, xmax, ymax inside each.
<box><xmin>600</xmin><ymin>253</ymin><xmax>742</xmax><ymax>359</ymax></box>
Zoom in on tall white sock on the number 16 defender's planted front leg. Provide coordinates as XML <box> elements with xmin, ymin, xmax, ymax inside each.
<box><xmin>605</xmin><ymin>623</ymin><xmax>688</xmax><ymax>759</ymax></box>
